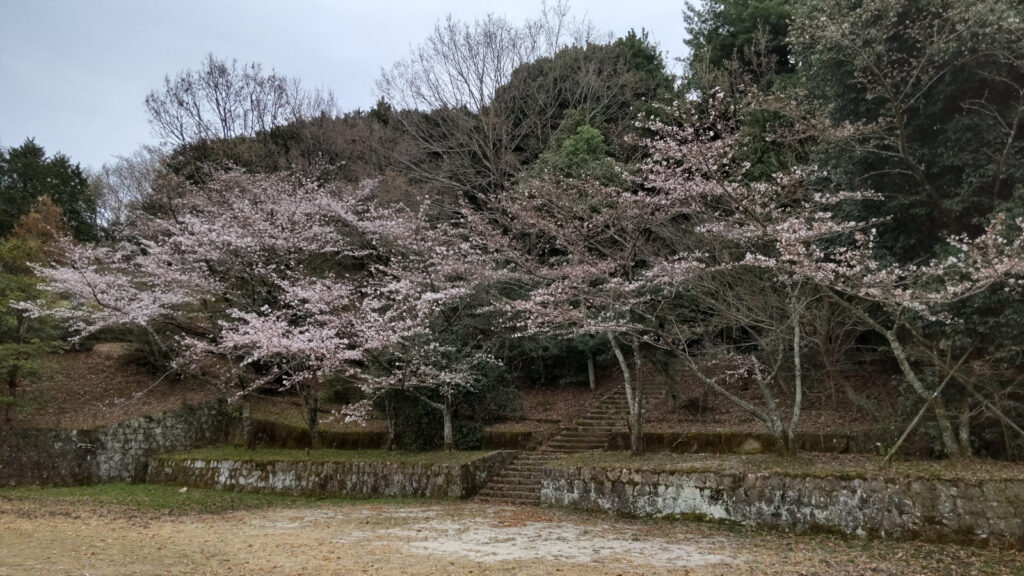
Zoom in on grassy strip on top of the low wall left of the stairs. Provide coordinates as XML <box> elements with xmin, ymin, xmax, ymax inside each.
<box><xmin>171</xmin><ymin>447</ymin><xmax>490</xmax><ymax>464</ymax></box>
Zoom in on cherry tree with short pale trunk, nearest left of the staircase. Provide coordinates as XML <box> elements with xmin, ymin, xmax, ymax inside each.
<box><xmin>359</xmin><ymin>198</ymin><xmax>508</xmax><ymax>451</ymax></box>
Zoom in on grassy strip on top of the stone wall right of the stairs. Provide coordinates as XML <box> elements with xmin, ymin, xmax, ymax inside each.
<box><xmin>554</xmin><ymin>452</ymin><xmax>1024</xmax><ymax>482</ymax></box>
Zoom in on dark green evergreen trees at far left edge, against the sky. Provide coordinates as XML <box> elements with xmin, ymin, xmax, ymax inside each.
<box><xmin>0</xmin><ymin>138</ymin><xmax>97</xmax><ymax>241</ymax></box>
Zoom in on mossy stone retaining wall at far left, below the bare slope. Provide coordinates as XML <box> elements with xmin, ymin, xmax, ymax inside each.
<box><xmin>0</xmin><ymin>403</ymin><xmax>228</xmax><ymax>486</ymax></box>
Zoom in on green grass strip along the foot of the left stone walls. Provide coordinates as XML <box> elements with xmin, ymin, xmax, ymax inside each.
<box><xmin>0</xmin><ymin>483</ymin><xmax>415</xmax><ymax>515</ymax></box>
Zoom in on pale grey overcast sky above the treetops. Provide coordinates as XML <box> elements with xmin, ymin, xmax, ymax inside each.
<box><xmin>0</xmin><ymin>0</ymin><xmax>684</xmax><ymax>167</ymax></box>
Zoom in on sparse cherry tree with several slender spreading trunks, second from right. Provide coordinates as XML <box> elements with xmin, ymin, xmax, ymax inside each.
<box><xmin>638</xmin><ymin>93</ymin><xmax>876</xmax><ymax>453</ymax></box>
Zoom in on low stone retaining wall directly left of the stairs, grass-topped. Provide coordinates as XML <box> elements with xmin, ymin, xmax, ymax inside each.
<box><xmin>146</xmin><ymin>451</ymin><xmax>516</xmax><ymax>498</ymax></box>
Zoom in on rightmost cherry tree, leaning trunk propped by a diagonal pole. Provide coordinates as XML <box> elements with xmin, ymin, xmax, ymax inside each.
<box><xmin>786</xmin><ymin>214</ymin><xmax>1024</xmax><ymax>457</ymax></box>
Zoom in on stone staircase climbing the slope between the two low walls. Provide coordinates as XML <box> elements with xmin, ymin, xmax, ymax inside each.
<box><xmin>474</xmin><ymin>386</ymin><xmax>666</xmax><ymax>505</ymax></box>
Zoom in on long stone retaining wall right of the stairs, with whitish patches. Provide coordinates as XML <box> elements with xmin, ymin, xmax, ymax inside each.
<box><xmin>541</xmin><ymin>467</ymin><xmax>1024</xmax><ymax>548</ymax></box>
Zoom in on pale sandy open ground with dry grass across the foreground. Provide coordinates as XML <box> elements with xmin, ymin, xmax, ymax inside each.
<box><xmin>0</xmin><ymin>500</ymin><xmax>1024</xmax><ymax>576</ymax></box>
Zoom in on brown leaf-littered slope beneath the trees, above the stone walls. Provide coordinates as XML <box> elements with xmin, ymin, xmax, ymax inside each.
<box><xmin>11</xmin><ymin>342</ymin><xmax>892</xmax><ymax>438</ymax></box>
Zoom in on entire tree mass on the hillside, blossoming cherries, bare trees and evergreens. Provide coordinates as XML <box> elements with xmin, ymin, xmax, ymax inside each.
<box><xmin>0</xmin><ymin>0</ymin><xmax>1024</xmax><ymax>459</ymax></box>
